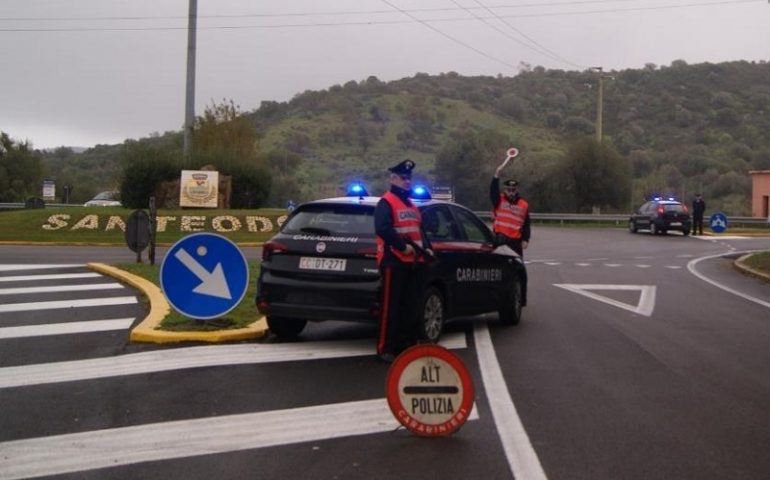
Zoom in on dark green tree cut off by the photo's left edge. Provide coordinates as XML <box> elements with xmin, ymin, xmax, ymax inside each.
<box><xmin>0</xmin><ymin>132</ymin><xmax>44</xmax><ymax>202</ymax></box>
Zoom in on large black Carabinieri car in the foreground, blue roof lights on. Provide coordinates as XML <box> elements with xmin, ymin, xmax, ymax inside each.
<box><xmin>256</xmin><ymin>188</ymin><xmax>525</xmax><ymax>342</ymax></box>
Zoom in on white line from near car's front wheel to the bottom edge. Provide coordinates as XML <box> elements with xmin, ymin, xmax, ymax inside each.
<box><xmin>474</xmin><ymin>323</ymin><xmax>547</xmax><ymax>480</ymax></box>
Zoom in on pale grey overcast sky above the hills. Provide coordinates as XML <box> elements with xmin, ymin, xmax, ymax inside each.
<box><xmin>0</xmin><ymin>0</ymin><xmax>770</xmax><ymax>148</ymax></box>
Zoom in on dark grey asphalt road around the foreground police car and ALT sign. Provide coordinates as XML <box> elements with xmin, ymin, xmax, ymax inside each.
<box><xmin>0</xmin><ymin>228</ymin><xmax>770</xmax><ymax>480</ymax></box>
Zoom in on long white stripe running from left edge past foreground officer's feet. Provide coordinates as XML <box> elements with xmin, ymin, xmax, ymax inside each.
<box><xmin>0</xmin><ymin>333</ymin><xmax>466</xmax><ymax>388</ymax></box>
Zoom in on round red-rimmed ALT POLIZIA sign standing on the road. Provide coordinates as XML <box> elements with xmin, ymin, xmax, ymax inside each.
<box><xmin>386</xmin><ymin>345</ymin><xmax>475</xmax><ymax>437</ymax></box>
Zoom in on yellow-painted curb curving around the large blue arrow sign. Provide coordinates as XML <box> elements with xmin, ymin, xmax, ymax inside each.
<box><xmin>88</xmin><ymin>263</ymin><xmax>268</xmax><ymax>343</ymax></box>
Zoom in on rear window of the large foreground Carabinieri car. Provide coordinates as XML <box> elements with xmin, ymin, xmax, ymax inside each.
<box><xmin>281</xmin><ymin>205</ymin><xmax>374</xmax><ymax>237</ymax></box>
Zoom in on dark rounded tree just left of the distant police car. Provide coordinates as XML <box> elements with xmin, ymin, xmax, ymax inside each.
<box><xmin>563</xmin><ymin>138</ymin><xmax>631</xmax><ymax>212</ymax></box>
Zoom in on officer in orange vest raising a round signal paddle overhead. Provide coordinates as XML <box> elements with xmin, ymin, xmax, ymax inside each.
<box><xmin>489</xmin><ymin>149</ymin><xmax>531</xmax><ymax>305</ymax></box>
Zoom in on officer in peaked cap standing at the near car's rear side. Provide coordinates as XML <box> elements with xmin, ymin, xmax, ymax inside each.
<box><xmin>374</xmin><ymin>159</ymin><xmax>430</xmax><ymax>362</ymax></box>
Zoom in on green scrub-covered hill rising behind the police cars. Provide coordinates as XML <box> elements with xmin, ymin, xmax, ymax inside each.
<box><xmin>40</xmin><ymin>61</ymin><xmax>770</xmax><ymax>215</ymax></box>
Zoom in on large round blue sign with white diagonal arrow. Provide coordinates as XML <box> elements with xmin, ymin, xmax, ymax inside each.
<box><xmin>160</xmin><ymin>233</ymin><xmax>249</xmax><ymax>320</ymax></box>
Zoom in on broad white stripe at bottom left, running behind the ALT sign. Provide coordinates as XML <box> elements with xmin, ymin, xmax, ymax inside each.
<box><xmin>0</xmin><ymin>398</ymin><xmax>478</xmax><ymax>480</ymax></box>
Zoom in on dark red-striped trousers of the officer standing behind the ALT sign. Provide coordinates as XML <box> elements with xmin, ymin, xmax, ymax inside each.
<box><xmin>377</xmin><ymin>262</ymin><xmax>422</xmax><ymax>355</ymax></box>
